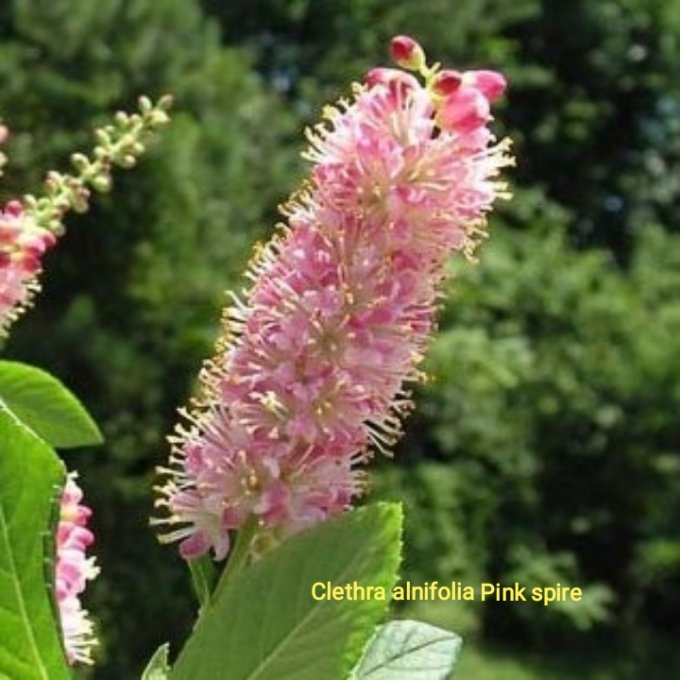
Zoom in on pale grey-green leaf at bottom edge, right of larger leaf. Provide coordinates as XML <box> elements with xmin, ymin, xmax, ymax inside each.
<box><xmin>350</xmin><ymin>621</ymin><xmax>462</xmax><ymax>680</ymax></box>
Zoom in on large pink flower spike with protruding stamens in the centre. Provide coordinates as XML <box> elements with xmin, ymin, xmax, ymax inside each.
<box><xmin>155</xmin><ymin>36</ymin><xmax>510</xmax><ymax>559</ymax></box>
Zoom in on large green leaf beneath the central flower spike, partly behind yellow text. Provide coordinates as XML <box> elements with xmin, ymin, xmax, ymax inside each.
<box><xmin>170</xmin><ymin>504</ymin><xmax>402</xmax><ymax>680</ymax></box>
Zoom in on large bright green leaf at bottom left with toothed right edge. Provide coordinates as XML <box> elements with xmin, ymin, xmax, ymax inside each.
<box><xmin>0</xmin><ymin>408</ymin><xmax>70</xmax><ymax>680</ymax></box>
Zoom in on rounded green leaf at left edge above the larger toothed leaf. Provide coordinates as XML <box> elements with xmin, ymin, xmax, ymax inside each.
<box><xmin>0</xmin><ymin>361</ymin><xmax>103</xmax><ymax>448</ymax></box>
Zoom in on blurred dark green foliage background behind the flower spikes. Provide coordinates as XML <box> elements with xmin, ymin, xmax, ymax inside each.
<box><xmin>0</xmin><ymin>0</ymin><xmax>680</xmax><ymax>678</ymax></box>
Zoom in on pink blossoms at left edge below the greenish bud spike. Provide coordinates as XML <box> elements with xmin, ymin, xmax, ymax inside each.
<box><xmin>0</xmin><ymin>201</ymin><xmax>56</xmax><ymax>337</ymax></box>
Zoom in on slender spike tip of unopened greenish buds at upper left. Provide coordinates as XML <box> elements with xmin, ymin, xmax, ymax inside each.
<box><xmin>24</xmin><ymin>95</ymin><xmax>172</xmax><ymax>235</ymax></box>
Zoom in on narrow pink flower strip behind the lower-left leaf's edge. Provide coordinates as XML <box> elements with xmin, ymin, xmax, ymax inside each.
<box><xmin>54</xmin><ymin>472</ymin><xmax>99</xmax><ymax>665</ymax></box>
